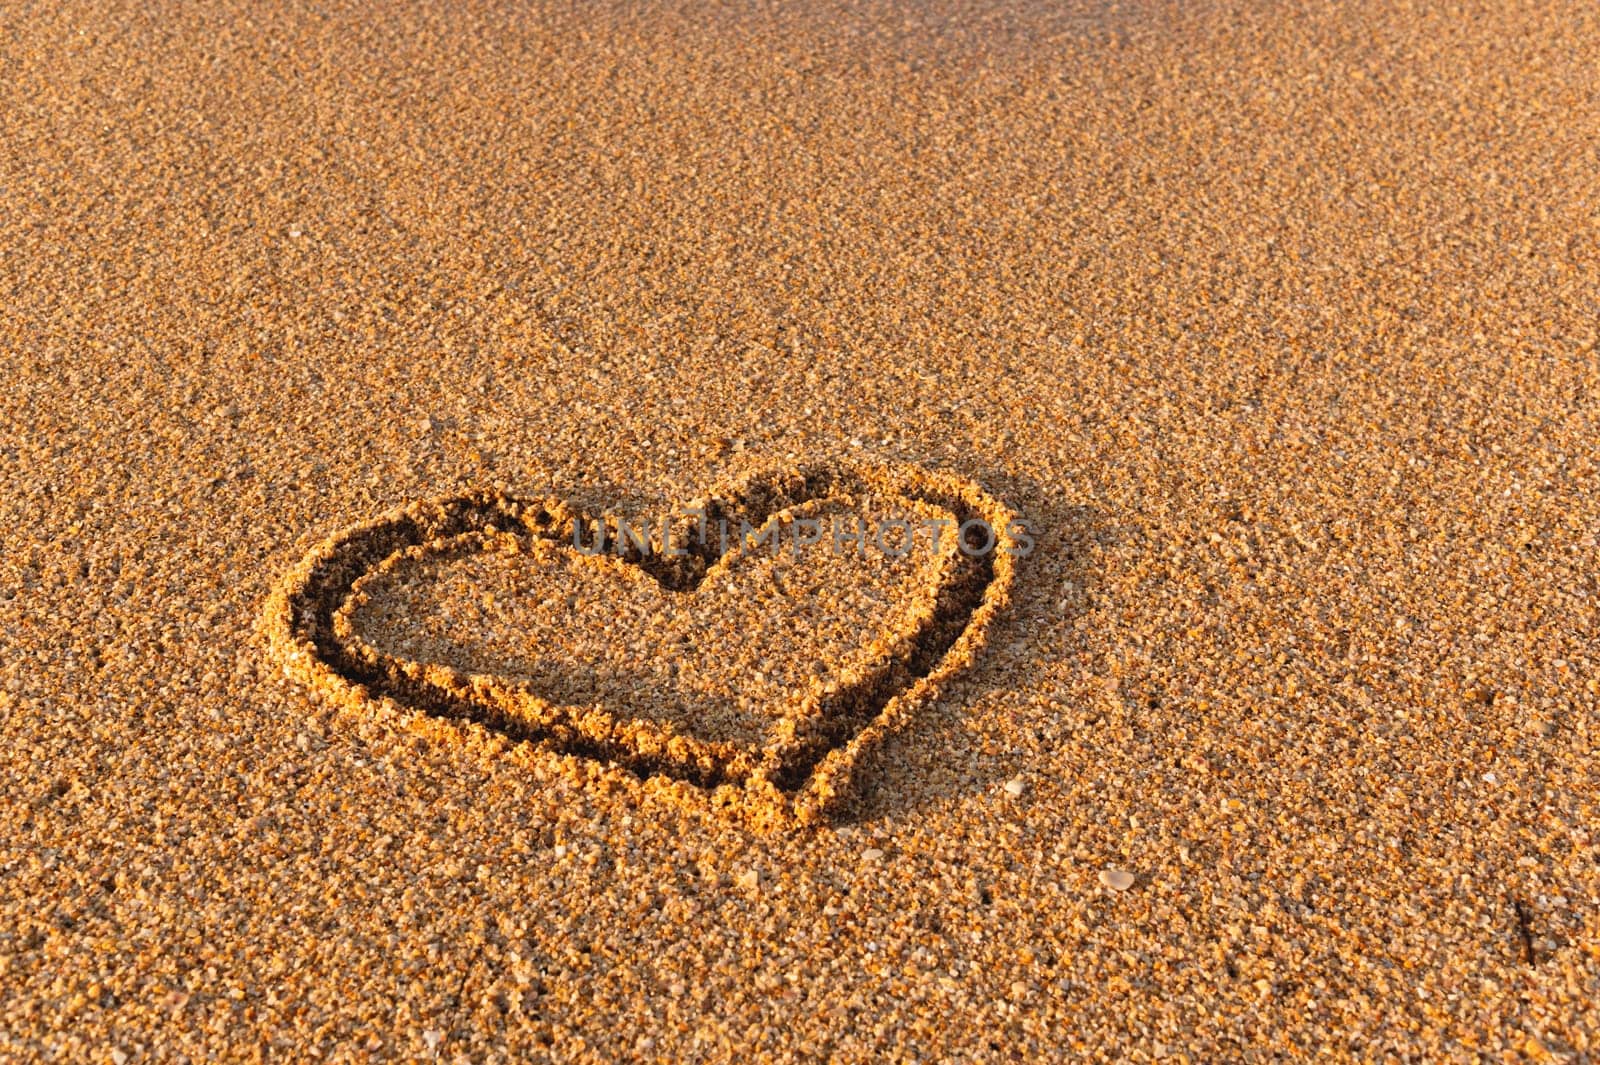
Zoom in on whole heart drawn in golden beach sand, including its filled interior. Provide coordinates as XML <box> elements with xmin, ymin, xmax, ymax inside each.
<box><xmin>264</xmin><ymin>464</ymin><xmax>1019</xmax><ymax>824</ymax></box>
